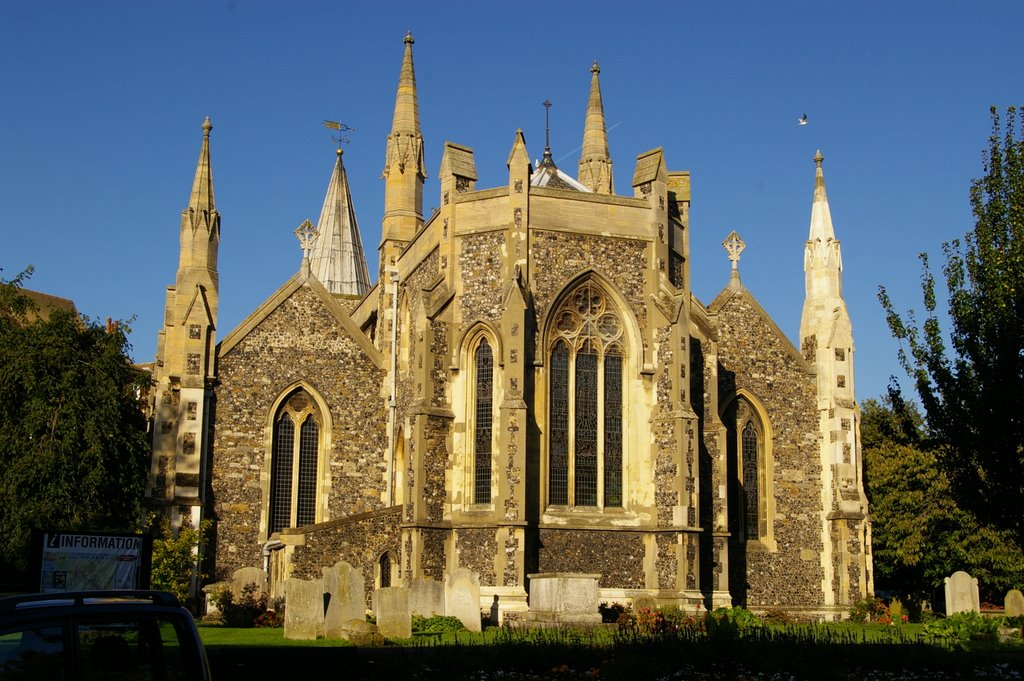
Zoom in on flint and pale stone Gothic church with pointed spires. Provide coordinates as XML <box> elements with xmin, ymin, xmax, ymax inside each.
<box><xmin>146</xmin><ymin>35</ymin><xmax>872</xmax><ymax>620</ymax></box>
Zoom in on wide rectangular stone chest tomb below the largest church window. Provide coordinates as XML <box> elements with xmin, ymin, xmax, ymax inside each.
<box><xmin>526</xmin><ymin>572</ymin><xmax>601</xmax><ymax>625</ymax></box>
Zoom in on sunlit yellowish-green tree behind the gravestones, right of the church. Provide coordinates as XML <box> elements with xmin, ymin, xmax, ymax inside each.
<box><xmin>861</xmin><ymin>399</ymin><xmax>1024</xmax><ymax>602</ymax></box>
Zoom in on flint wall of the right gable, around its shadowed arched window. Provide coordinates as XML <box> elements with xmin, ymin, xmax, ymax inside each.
<box><xmin>719</xmin><ymin>295</ymin><xmax>824</xmax><ymax>607</ymax></box>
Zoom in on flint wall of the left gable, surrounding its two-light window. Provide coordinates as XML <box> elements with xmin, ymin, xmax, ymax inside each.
<box><xmin>210</xmin><ymin>287</ymin><xmax>387</xmax><ymax>579</ymax></box>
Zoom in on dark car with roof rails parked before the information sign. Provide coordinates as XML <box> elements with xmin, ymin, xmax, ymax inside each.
<box><xmin>0</xmin><ymin>591</ymin><xmax>210</xmax><ymax>681</ymax></box>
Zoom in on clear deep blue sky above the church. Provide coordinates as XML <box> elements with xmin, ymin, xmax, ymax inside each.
<box><xmin>0</xmin><ymin>0</ymin><xmax>1024</xmax><ymax>399</ymax></box>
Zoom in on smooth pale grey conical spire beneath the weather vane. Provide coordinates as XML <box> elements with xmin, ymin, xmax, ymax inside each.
<box><xmin>309</xmin><ymin>148</ymin><xmax>370</xmax><ymax>296</ymax></box>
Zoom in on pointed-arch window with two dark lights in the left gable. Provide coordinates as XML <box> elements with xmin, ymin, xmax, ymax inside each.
<box><xmin>267</xmin><ymin>390</ymin><xmax>321</xmax><ymax>535</ymax></box>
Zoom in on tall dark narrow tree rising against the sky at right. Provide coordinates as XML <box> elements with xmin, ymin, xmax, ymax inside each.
<box><xmin>879</xmin><ymin>108</ymin><xmax>1024</xmax><ymax>545</ymax></box>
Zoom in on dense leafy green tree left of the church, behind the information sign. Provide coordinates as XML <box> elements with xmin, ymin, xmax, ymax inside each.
<box><xmin>0</xmin><ymin>270</ymin><xmax>150</xmax><ymax>579</ymax></box>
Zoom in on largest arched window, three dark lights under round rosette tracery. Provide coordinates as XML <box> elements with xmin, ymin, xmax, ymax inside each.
<box><xmin>548</xmin><ymin>282</ymin><xmax>624</xmax><ymax>508</ymax></box>
